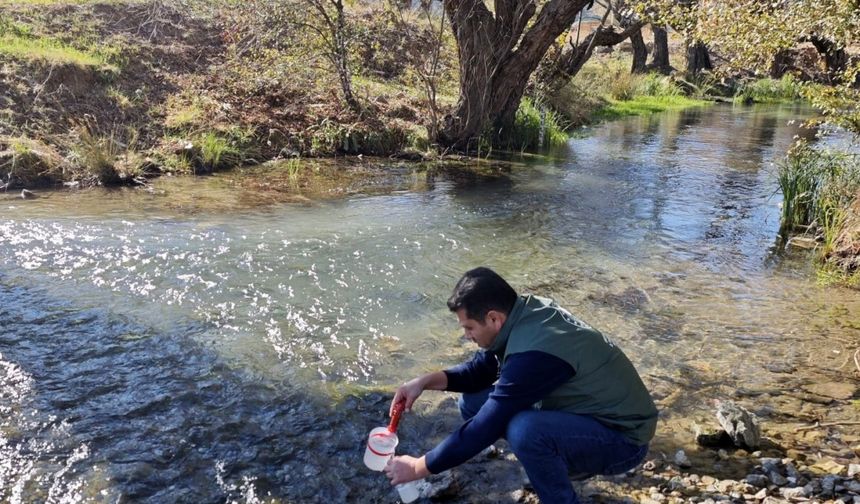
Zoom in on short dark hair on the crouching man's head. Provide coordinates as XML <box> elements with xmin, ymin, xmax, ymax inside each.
<box><xmin>448</xmin><ymin>267</ymin><xmax>517</xmax><ymax>322</ymax></box>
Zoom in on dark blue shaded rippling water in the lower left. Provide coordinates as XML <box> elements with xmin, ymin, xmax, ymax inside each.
<box><xmin>0</xmin><ymin>277</ymin><xmax>470</xmax><ymax>503</ymax></box>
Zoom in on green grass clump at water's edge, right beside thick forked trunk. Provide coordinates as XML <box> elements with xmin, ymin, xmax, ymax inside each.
<box><xmin>509</xmin><ymin>98</ymin><xmax>568</xmax><ymax>150</ymax></box>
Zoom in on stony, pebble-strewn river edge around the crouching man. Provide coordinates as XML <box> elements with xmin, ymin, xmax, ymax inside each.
<box><xmin>362</xmin><ymin>383</ymin><xmax>860</xmax><ymax>504</ymax></box>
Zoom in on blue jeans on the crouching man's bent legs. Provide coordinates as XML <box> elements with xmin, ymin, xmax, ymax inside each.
<box><xmin>459</xmin><ymin>387</ymin><xmax>648</xmax><ymax>504</ymax></box>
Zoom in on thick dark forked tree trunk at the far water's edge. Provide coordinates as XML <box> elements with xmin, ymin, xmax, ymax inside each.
<box><xmin>437</xmin><ymin>0</ymin><xmax>588</xmax><ymax>150</ymax></box>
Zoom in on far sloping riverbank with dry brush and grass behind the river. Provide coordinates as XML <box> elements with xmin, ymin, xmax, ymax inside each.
<box><xmin>0</xmin><ymin>0</ymin><xmax>752</xmax><ymax>190</ymax></box>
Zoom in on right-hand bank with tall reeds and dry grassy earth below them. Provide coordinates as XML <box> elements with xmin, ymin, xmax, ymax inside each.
<box><xmin>778</xmin><ymin>144</ymin><xmax>860</xmax><ymax>287</ymax></box>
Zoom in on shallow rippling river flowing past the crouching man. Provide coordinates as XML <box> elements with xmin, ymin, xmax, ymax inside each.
<box><xmin>0</xmin><ymin>106</ymin><xmax>860</xmax><ymax>503</ymax></box>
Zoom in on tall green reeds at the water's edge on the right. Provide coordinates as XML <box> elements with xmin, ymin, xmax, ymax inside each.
<box><xmin>777</xmin><ymin>143</ymin><xmax>860</xmax><ymax>255</ymax></box>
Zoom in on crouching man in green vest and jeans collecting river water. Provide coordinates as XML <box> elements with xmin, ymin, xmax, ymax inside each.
<box><xmin>385</xmin><ymin>268</ymin><xmax>657</xmax><ymax>504</ymax></box>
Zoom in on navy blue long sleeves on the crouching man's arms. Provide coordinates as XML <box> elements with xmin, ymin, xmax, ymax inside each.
<box><xmin>425</xmin><ymin>351</ymin><xmax>575</xmax><ymax>474</ymax></box>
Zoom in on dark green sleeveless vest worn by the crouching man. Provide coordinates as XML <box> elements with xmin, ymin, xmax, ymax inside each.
<box><xmin>489</xmin><ymin>295</ymin><xmax>657</xmax><ymax>445</ymax></box>
